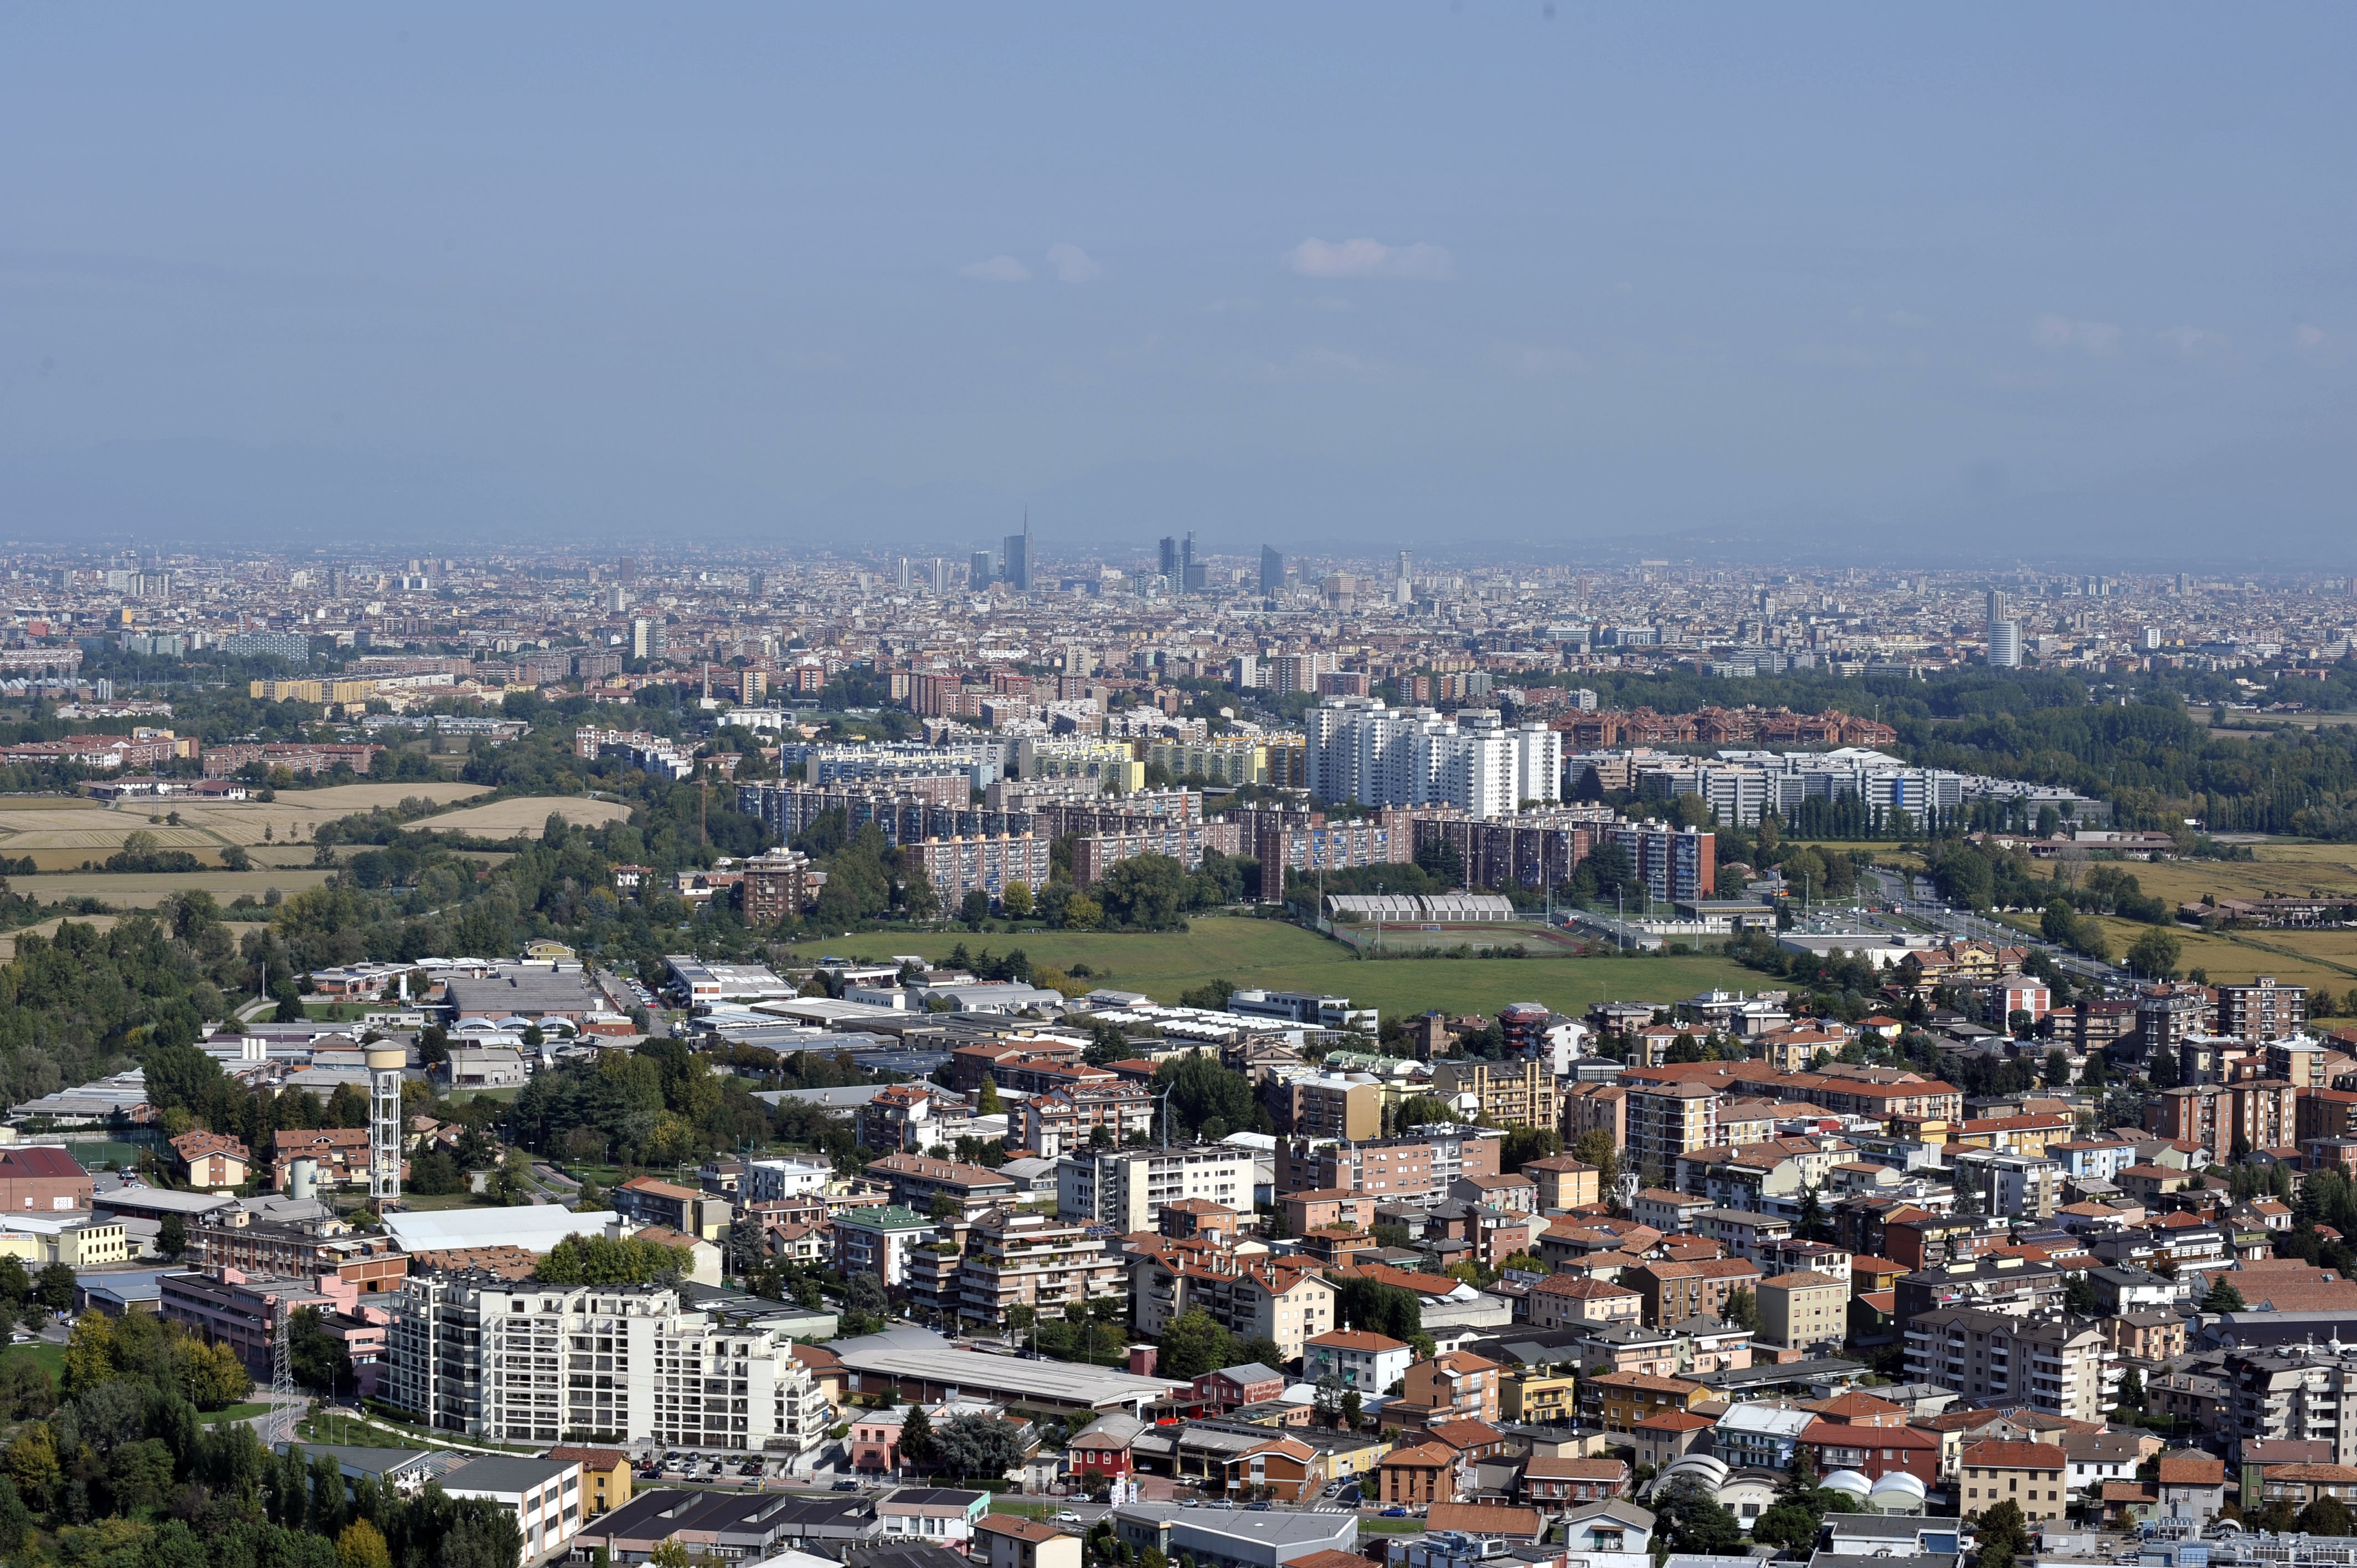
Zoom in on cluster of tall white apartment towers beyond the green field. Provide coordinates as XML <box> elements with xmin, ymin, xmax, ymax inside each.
<box><xmin>1304</xmin><ymin>698</ymin><xmax>1563</xmax><ymax>818</ymax></box>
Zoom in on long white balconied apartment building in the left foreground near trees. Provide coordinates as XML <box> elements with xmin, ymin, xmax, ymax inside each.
<box><xmin>384</xmin><ymin>1273</ymin><xmax>835</xmax><ymax>1452</ymax></box>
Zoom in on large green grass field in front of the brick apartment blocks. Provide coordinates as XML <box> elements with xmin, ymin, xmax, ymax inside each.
<box><xmin>794</xmin><ymin>915</ymin><xmax>1761</xmax><ymax>1016</ymax></box>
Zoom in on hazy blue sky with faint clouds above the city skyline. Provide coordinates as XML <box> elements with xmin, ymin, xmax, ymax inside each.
<box><xmin>0</xmin><ymin>0</ymin><xmax>2357</xmax><ymax>571</ymax></box>
